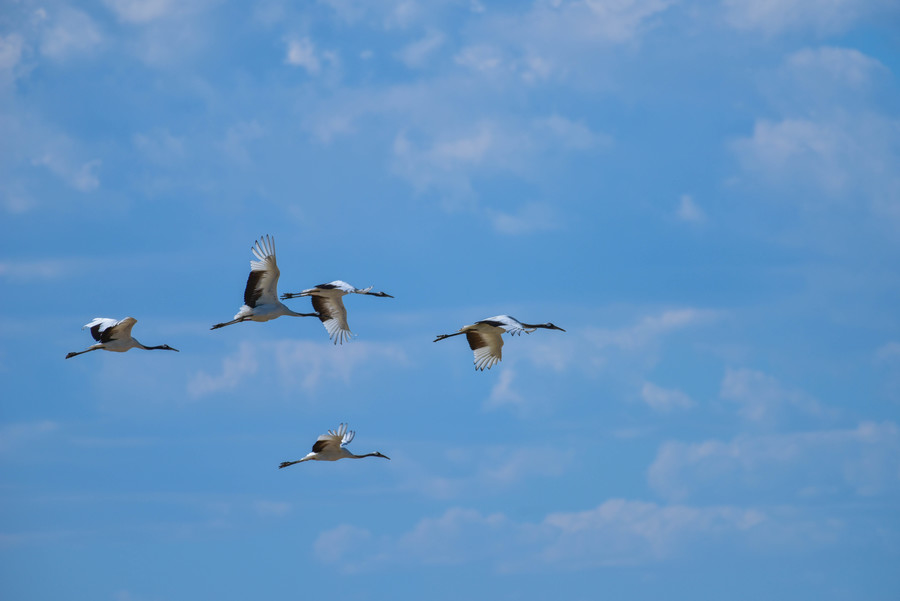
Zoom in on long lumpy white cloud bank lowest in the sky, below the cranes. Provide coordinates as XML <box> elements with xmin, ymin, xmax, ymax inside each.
<box><xmin>315</xmin><ymin>499</ymin><xmax>774</xmax><ymax>572</ymax></box>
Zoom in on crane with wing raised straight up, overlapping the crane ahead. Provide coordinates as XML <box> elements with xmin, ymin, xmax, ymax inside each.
<box><xmin>210</xmin><ymin>236</ymin><xmax>318</xmax><ymax>330</ymax></box>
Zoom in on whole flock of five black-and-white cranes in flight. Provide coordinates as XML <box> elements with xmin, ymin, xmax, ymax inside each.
<box><xmin>66</xmin><ymin>235</ymin><xmax>565</xmax><ymax>468</ymax></box>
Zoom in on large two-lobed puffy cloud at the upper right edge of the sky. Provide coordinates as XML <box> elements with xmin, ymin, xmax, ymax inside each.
<box><xmin>732</xmin><ymin>47</ymin><xmax>900</xmax><ymax>217</ymax></box>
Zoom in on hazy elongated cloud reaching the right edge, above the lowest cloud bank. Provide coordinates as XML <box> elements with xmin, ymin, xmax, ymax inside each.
<box><xmin>648</xmin><ymin>422</ymin><xmax>900</xmax><ymax>503</ymax></box>
